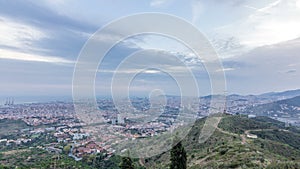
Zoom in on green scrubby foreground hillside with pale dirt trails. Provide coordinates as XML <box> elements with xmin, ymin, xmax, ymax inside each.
<box><xmin>146</xmin><ymin>115</ymin><xmax>300</xmax><ymax>169</ymax></box>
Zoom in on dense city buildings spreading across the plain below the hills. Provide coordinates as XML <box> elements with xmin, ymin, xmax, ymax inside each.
<box><xmin>0</xmin><ymin>90</ymin><xmax>300</xmax><ymax>164</ymax></box>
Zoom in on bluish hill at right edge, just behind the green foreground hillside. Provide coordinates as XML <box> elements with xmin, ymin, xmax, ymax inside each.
<box><xmin>244</xmin><ymin>95</ymin><xmax>300</xmax><ymax>119</ymax></box>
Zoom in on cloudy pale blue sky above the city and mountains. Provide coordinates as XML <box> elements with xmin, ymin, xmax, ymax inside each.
<box><xmin>0</xmin><ymin>0</ymin><xmax>300</xmax><ymax>101</ymax></box>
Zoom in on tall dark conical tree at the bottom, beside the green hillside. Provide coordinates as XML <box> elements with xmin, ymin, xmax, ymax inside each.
<box><xmin>170</xmin><ymin>141</ymin><xmax>187</xmax><ymax>169</ymax></box>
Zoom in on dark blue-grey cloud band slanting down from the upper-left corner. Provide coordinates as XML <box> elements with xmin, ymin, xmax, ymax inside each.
<box><xmin>0</xmin><ymin>0</ymin><xmax>97</xmax><ymax>32</ymax></box>
